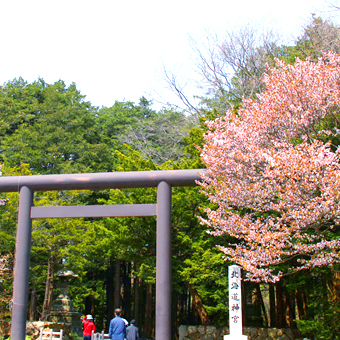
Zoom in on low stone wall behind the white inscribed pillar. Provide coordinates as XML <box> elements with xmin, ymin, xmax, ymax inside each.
<box><xmin>179</xmin><ymin>326</ymin><xmax>297</xmax><ymax>340</ymax></box>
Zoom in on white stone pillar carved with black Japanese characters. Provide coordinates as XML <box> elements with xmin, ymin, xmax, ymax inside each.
<box><xmin>223</xmin><ymin>265</ymin><xmax>248</xmax><ymax>340</ymax></box>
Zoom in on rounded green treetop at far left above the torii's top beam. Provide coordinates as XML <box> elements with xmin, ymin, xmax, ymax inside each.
<box><xmin>0</xmin><ymin>79</ymin><xmax>110</xmax><ymax>174</ymax></box>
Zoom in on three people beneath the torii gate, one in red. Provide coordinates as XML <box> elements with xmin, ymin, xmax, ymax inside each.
<box><xmin>83</xmin><ymin>308</ymin><xmax>139</xmax><ymax>340</ymax></box>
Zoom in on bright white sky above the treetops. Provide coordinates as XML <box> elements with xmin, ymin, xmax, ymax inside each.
<box><xmin>0</xmin><ymin>0</ymin><xmax>336</xmax><ymax>106</ymax></box>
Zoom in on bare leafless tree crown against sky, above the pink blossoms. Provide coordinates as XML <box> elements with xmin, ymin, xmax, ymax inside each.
<box><xmin>190</xmin><ymin>25</ymin><xmax>278</xmax><ymax>111</ymax></box>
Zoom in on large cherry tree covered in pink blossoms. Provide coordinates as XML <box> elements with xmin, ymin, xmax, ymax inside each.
<box><xmin>201</xmin><ymin>52</ymin><xmax>340</xmax><ymax>282</ymax></box>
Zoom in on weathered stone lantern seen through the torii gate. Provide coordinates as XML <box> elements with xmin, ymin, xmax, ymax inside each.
<box><xmin>50</xmin><ymin>270</ymin><xmax>83</xmax><ymax>336</ymax></box>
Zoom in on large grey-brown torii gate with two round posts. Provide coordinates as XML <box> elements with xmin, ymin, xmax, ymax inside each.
<box><xmin>0</xmin><ymin>169</ymin><xmax>204</xmax><ymax>340</ymax></box>
